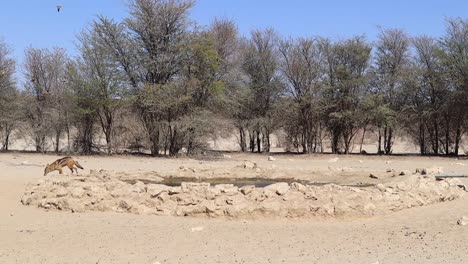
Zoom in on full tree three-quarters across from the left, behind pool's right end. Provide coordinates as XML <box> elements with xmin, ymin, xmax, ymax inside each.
<box><xmin>321</xmin><ymin>37</ymin><xmax>372</xmax><ymax>154</ymax></box>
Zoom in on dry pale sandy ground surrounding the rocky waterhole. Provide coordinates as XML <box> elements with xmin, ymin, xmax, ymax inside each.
<box><xmin>0</xmin><ymin>153</ymin><xmax>468</xmax><ymax>264</ymax></box>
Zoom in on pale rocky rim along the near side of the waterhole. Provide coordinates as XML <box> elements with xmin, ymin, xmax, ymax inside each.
<box><xmin>21</xmin><ymin>173</ymin><xmax>466</xmax><ymax>218</ymax></box>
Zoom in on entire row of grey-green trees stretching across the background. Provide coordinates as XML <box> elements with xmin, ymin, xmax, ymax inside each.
<box><xmin>0</xmin><ymin>0</ymin><xmax>468</xmax><ymax>155</ymax></box>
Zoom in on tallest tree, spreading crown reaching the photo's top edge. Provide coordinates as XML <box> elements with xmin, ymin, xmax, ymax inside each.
<box><xmin>94</xmin><ymin>0</ymin><xmax>193</xmax><ymax>156</ymax></box>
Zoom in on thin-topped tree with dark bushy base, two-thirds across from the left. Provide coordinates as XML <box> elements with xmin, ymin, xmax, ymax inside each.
<box><xmin>279</xmin><ymin>38</ymin><xmax>323</xmax><ymax>153</ymax></box>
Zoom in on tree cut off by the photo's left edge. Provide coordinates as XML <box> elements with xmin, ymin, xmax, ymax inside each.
<box><xmin>0</xmin><ymin>38</ymin><xmax>21</xmax><ymax>151</ymax></box>
